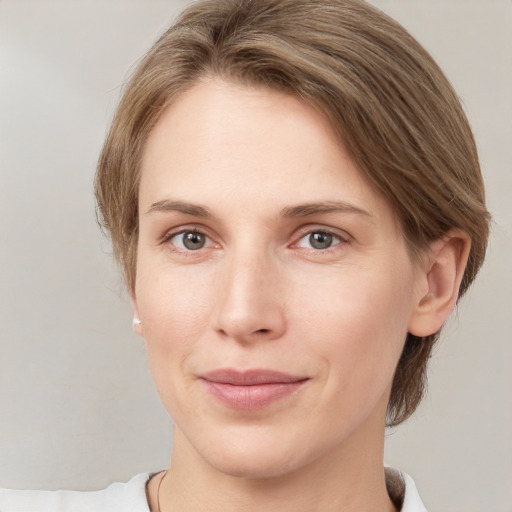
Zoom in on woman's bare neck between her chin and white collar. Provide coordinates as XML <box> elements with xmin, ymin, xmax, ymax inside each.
<box><xmin>160</xmin><ymin>429</ymin><xmax>396</xmax><ymax>512</ymax></box>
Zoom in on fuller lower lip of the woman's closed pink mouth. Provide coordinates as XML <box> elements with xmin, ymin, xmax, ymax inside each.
<box><xmin>204</xmin><ymin>380</ymin><xmax>305</xmax><ymax>411</ymax></box>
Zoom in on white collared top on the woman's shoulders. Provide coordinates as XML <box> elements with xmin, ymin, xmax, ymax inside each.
<box><xmin>0</xmin><ymin>468</ymin><xmax>427</xmax><ymax>512</ymax></box>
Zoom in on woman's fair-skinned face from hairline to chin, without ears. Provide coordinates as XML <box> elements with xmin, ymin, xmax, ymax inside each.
<box><xmin>133</xmin><ymin>79</ymin><xmax>420</xmax><ymax>476</ymax></box>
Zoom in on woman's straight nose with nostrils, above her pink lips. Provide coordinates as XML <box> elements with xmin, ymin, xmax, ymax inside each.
<box><xmin>210</xmin><ymin>249</ymin><xmax>286</xmax><ymax>343</ymax></box>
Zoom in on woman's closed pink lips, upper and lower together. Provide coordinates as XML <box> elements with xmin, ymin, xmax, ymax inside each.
<box><xmin>201</xmin><ymin>369</ymin><xmax>308</xmax><ymax>411</ymax></box>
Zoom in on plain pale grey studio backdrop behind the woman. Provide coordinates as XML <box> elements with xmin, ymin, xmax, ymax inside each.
<box><xmin>0</xmin><ymin>0</ymin><xmax>512</xmax><ymax>512</ymax></box>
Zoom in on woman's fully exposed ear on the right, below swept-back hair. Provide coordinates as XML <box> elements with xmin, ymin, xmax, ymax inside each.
<box><xmin>409</xmin><ymin>229</ymin><xmax>471</xmax><ymax>337</ymax></box>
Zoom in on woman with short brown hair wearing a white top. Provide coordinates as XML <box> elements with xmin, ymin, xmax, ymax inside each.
<box><xmin>0</xmin><ymin>0</ymin><xmax>488</xmax><ymax>512</ymax></box>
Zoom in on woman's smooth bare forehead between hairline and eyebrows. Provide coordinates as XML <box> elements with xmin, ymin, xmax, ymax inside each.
<box><xmin>140</xmin><ymin>79</ymin><xmax>396</xmax><ymax>224</ymax></box>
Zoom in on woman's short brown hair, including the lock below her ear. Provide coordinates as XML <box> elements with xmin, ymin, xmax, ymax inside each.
<box><xmin>95</xmin><ymin>0</ymin><xmax>489</xmax><ymax>425</ymax></box>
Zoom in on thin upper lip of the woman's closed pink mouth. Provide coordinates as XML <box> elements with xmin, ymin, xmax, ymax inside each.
<box><xmin>201</xmin><ymin>368</ymin><xmax>307</xmax><ymax>386</ymax></box>
